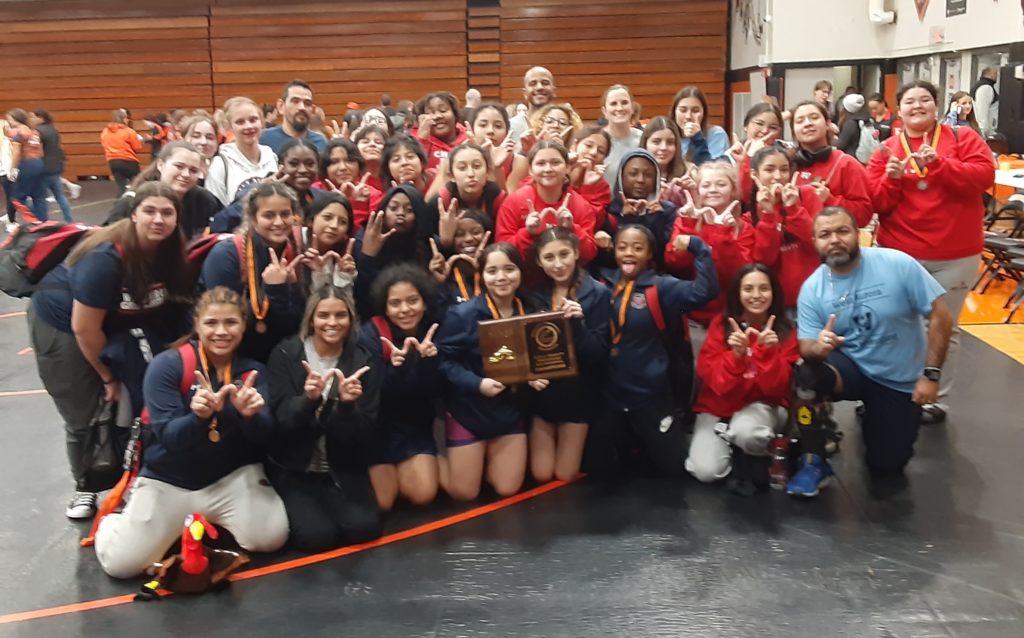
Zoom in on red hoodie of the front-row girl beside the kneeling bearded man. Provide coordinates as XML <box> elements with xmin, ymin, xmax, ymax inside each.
<box><xmin>693</xmin><ymin>314</ymin><xmax>800</xmax><ymax>417</ymax></box>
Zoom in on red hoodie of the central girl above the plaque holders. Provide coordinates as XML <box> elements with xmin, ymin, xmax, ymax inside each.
<box><xmin>495</xmin><ymin>183</ymin><xmax>604</xmax><ymax>262</ymax></box>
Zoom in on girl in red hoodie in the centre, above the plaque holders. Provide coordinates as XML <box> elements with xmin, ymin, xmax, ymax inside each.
<box><xmin>496</xmin><ymin>139</ymin><xmax>608</xmax><ymax>263</ymax></box>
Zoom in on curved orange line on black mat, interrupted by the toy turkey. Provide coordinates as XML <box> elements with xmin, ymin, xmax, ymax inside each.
<box><xmin>0</xmin><ymin>480</ymin><xmax>572</xmax><ymax>625</ymax></box>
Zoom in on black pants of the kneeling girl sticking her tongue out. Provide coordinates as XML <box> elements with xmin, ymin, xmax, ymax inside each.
<box><xmin>585</xmin><ymin>396</ymin><xmax>688</xmax><ymax>476</ymax></box>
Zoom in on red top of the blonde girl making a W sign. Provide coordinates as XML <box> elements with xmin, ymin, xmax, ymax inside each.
<box><xmin>665</xmin><ymin>213</ymin><xmax>754</xmax><ymax>326</ymax></box>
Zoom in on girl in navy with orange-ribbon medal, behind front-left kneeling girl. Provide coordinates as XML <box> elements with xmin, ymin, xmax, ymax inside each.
<box><xmin>200</xmin><ymin>182</ymin><xmax>305</xmax><ymax>361</ymax></box>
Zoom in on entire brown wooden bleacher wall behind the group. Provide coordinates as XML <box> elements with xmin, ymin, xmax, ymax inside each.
<box><xmin>0</xmin><ymin>0</ymin><xmax>728</xmax><ymax>175</ymax></box>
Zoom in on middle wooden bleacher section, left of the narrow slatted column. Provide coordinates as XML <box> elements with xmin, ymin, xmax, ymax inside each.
<box><xmin>210</xmin><ymin>0</ymin><xmax>467</xmax><ymax>119</ymax></box>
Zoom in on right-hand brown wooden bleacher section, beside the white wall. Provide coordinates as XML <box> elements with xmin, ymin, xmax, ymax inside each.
<box><xmin>501</xmin><ymin>0</ymin><xmax>729</xmax><ymax>122</ymax></box>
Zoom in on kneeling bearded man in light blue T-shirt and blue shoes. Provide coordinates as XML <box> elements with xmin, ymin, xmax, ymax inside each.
<box><xmin>786</xmin><ymin>206</ymin><xmax>953</xmax><ymax>497</ymax></box>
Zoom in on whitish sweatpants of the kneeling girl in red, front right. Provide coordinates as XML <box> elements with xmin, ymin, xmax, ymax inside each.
<box><xmin>686</xmin><ymin>401</ymin><xmax>786</xmax><ymax>483</ymax></box>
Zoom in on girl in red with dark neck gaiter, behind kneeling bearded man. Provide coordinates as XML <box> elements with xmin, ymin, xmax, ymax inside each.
<box><xmin>792</xmin><ymin>100</ymin><xmax>874</xmax><ymax>226</ymax></box>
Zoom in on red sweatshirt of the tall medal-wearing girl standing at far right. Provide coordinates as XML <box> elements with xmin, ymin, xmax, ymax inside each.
<box><xmin>867</xmin><ymin>124</ymin><xmax>995</xmax><ymax>260</ymax></box>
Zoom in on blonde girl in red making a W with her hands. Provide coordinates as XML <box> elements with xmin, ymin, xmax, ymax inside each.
<box><xmin>665</xmin><ymin>160</ymin><xmax>754</xmax><ymax>347</ymax></box>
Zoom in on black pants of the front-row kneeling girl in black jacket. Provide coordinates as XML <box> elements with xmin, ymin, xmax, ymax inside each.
<box><xmin>266</xmin><ymin>464</ymin><xmax>381</xmax><ymax>552</ymax></box>
